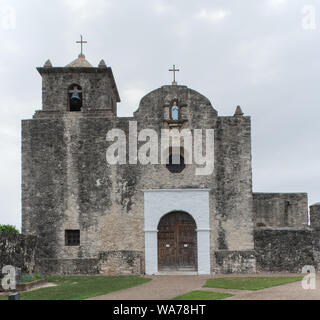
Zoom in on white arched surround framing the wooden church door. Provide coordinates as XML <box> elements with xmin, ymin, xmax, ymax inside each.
<box><xmin>143</xmin><ymin>189</ymin><xmax>211</xmax><ymax>275</ymax></box>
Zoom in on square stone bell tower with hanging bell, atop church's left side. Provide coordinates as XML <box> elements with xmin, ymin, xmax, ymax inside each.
<box><xmin>36</xmin><ymin>41</ymin><xmax>120</xmax><ymax>117</ymax></box>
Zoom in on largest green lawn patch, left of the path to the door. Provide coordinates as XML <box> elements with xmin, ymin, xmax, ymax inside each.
<box><xmin>0</xmin><ymin>276</ymin><xmax>151</xmax><ymax>300</ymax></box>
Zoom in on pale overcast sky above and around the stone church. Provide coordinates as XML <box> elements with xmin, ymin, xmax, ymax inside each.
<box><xmin>0</xmin><ymin>0</ymin><xmax>320</xmax><ymax>228</ymax></box>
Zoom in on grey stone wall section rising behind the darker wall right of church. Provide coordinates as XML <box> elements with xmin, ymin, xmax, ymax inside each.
<box><xmin>253</xmin><ymin>193</ymin><xmax>308</xmax><ymax>228</ymax></box>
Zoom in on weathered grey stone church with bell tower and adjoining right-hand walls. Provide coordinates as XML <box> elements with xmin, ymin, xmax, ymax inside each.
<box><xmin>22</xmin><ymin>54</ymin><xmax>320</xmax><ymax>275</ymax></box>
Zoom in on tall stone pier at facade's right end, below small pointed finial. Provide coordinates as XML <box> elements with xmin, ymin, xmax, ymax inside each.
<box><xmin>212</xmin><ymin>117</ymin><xmax>254</xmax><ymax>252</ymax></box>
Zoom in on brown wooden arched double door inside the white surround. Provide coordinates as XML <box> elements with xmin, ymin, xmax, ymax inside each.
<box><xmin>158</xmin><ymin>212</ymin><xmax>197</xmax><ymax>271</ymax></box>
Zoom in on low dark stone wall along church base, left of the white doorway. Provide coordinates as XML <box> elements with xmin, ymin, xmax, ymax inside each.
<box><xmin>0</xmin><ymin>233</ymin><xmax>144</xmax><ymax>275</ymax></box>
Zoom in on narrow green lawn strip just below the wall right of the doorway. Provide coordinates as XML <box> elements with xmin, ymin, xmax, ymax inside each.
<box><xmin>204</xmin><ymin>276</ymin><xmax>303</xmax><ymax>291</ymax></box>
